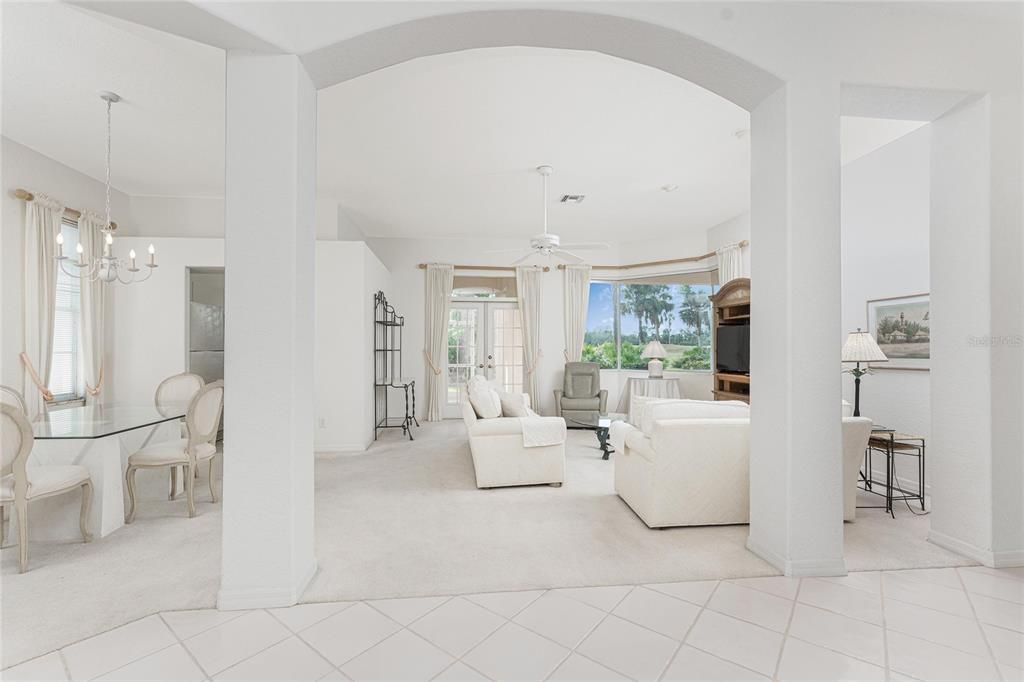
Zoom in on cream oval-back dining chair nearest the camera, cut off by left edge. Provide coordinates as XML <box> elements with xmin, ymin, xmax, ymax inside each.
<box><xmin>0</xmin><ymin>403</ymin><xmax>92</xmax><ymax>573</ymax></box>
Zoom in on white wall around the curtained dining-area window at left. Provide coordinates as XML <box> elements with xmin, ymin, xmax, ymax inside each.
<box><xmin>0</xmin><ymin>137</ymin><xmax>131</xmax><ymax>401</ymax></box>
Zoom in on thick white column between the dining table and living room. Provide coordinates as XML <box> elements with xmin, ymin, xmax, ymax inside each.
<box><xmin>217</xmin><ymin>51</ymin><xmax>316</xmax><ymax>608</ymax></box>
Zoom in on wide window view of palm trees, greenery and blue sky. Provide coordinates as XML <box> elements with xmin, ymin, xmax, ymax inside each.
<box><xmin>583</xmin><ymin>282</ymin><xmax>715</xmax><ymax>370</ymax></box>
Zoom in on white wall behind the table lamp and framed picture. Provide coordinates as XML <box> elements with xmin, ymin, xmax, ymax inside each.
<box><xmin>839</xmin><ymin>126</ymin><xmax>931</xmax><ymax>475</ymax></box>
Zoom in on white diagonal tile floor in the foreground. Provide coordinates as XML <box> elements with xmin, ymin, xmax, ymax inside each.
<box><xmin>3</xmin><ymin>567</ymin><xmax>1024</xmax><ymax>680</ymax></box>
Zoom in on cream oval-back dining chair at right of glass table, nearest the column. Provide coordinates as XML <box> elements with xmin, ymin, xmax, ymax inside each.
<box><xmin>125</xmin><ymin>381</ymin><xmax>224</xmax><ymax>523</ymax></box>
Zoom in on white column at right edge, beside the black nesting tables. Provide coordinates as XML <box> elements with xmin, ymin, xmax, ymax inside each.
<box><xmin>928</xmin><ymin>95</ymin><xmax>1024</xmax><ymax>567</ymax></box>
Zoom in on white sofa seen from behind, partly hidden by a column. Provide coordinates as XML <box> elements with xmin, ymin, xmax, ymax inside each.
<box><xmin>610</xmin><ymin>400</ymin><xmax>871</xmax><ymax>528</ymax></box>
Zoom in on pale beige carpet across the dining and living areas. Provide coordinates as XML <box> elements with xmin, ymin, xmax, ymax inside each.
<box><xmin>2</xmin><ymin>422</ymin><xmax>972</xmax><ymax>668</ymax></box>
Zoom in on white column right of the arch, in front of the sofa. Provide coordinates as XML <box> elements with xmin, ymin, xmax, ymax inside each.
<box><xmin>748</xmin><ymin>76</ymin><xmax>846</xmax><ymax>576</ymax></box>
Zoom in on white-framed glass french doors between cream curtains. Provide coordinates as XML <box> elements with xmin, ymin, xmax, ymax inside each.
<box><xmin>444</xmin><ymin>301</ymin><xmax>524</xmax><ymax>419</ymax></box>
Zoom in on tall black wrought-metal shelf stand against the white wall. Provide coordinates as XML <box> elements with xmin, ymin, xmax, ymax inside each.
<box><xmin>374</xmin><ymin>291</ymin><xmax>420</xmax><ymax>440</ymax></box>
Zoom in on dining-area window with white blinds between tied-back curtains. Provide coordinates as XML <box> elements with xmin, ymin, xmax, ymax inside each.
<box><xmin>49</xmin><ymin>222</ymin><xmax>84</xmax><ymax>402</ymax></box>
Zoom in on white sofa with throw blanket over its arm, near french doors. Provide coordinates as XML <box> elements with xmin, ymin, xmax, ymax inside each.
<box><xmin>462</xmin><ymin>395</ymin><xmax>565</xmax><ymax>487</ymax></box>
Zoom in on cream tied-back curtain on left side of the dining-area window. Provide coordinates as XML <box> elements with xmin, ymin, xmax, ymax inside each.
<box><xmin>22</xmin><ymin>195</ymin><xmax>65</xmax><ymax>417</ymax></box>
